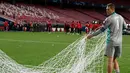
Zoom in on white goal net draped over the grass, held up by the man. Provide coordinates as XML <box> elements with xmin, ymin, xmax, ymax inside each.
<box><xmin>0</xmin><ymin>34</ymin><xmax>106</xmax><ymax>73</ymax></box>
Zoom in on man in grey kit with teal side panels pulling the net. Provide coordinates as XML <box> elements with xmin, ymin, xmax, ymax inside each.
<box><xmin>87</xmin><ymin>3</ymin><xmax>126</xmax><ymax>73</ymax></box>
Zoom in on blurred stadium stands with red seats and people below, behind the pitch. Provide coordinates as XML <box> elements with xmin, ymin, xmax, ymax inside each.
<box><xmin>0</xmin><ymin>0</ymin><xmax>130</xmax><ymax>34</ymax></box>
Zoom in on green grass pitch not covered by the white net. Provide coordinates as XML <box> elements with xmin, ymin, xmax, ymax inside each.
<box><xmin>0</xmin><ymin>32</ymin><xmax>130</xmax><ymax>73</ymax></box>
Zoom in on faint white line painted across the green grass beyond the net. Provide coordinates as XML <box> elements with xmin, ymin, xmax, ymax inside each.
<box><xmin>0</xmin><ymin>39</ymin><xmax>70</xmax><ymax>44</ymax></box>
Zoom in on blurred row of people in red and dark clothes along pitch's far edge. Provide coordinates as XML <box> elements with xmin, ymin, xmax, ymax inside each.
<box><xmin>0</xmin><ymin>20</ymin><xmax>102</xmax><ymax>34</ymax></box>
